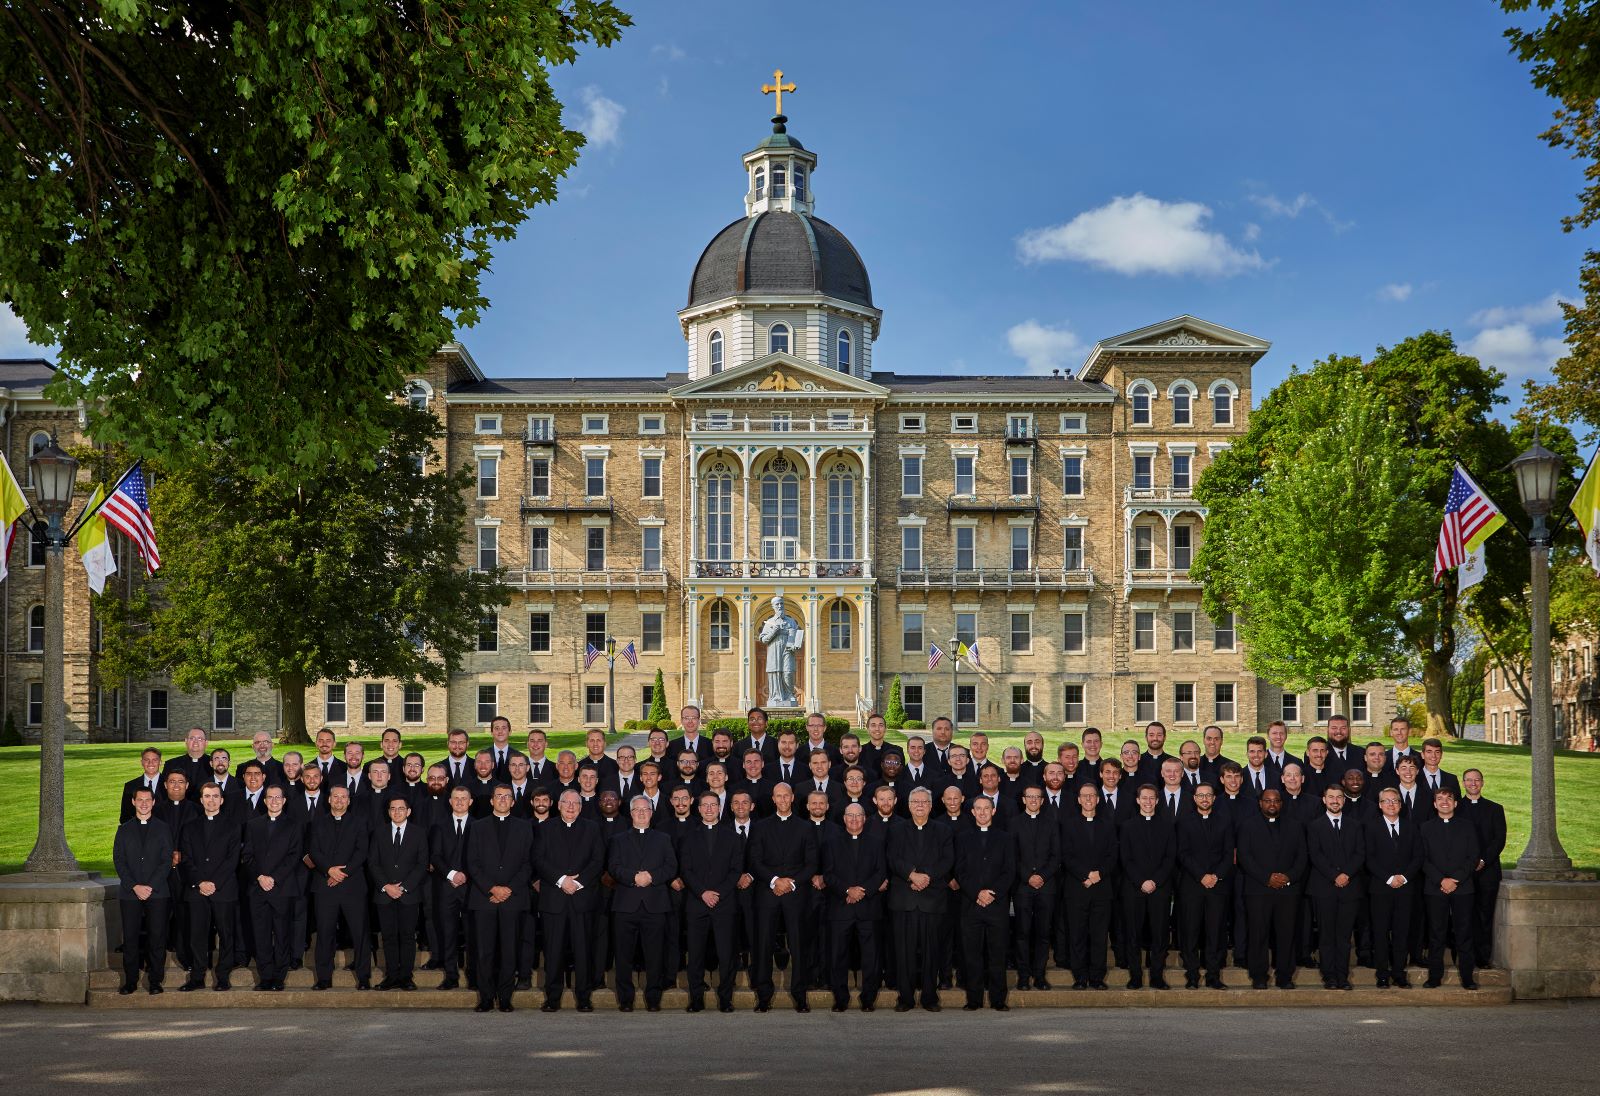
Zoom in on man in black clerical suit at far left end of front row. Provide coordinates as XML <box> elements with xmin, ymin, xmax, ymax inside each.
<box><xmin>110</xmin><ymin>784</ymin><xmax>178</xmax><ymax>995</ymax></box>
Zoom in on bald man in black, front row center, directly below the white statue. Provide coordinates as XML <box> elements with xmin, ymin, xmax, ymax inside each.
<box><xmin>746</xmin><ymin>784</ymin><xmax>818</xmax><ymax>1013</ymax></box>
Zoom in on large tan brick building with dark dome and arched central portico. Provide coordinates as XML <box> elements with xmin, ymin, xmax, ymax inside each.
<box><xmin>0</xmin><ymin>120</ymin><xmax>1394</xmax><ymax>739</ymax></box>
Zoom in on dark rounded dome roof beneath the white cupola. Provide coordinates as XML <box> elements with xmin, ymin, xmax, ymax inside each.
<box><xmin>688</xmin><ymin>211</ymin><xmax>872</xmax><ymax>307</ymax></box>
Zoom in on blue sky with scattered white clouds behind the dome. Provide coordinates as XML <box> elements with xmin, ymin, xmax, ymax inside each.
<box><xmin>0</xmin><ymin>0</ymin><xmax>1574</xmax><ymax>405</ymax></box>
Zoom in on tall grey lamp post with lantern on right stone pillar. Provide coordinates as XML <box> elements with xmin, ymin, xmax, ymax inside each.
<box><xmin>1510</xmin><ymin>427</ymin><xmax>1573</xmax><ymax>878</ymax></box>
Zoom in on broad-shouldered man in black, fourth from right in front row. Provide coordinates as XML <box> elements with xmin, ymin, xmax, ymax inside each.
<box><xmin>1237</xmin><ymin>787</ymin><xmax>1306</xmax><ymax>989</ymax></box>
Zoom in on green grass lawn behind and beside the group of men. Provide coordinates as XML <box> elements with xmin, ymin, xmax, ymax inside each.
<box><xmin>0</xmin><ymin>728</ymin><xmax>1600</xmax><ymax>872</ymax></box>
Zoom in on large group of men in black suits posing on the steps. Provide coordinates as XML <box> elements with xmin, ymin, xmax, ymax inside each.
<box><xmin>117</xmin><ymin>706</ymin><xmax>1504</xmax><ymax>1011</ymax></box>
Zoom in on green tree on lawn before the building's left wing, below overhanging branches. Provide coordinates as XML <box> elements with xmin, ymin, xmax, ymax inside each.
<box><xmin>96</xmin><ymin>402</ymin><xmax>509</xmax><ymax>742</ymax></box>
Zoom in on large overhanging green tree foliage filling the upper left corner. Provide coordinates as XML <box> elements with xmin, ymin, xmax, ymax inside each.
<box><xmin>0</xmin><ymin>0</ymin><xmax>630</xmax><ymax>480</ymax></box>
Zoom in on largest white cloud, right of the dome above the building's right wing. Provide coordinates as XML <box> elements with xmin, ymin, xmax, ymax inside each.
<box><xmin>1016</xmin><ymin>194</ymin><xmax>1267</xmax><ymax>277</ymax></box>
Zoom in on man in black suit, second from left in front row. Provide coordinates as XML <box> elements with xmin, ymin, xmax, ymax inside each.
<box><xmin>179</xmin><ymin>782</ymin><xmax>240</xmax><ymax>992</ymax></box>
